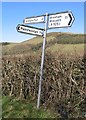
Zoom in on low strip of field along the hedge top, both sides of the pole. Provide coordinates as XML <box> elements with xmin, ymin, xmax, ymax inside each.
<box><xmin>2</xmin><ymin>43</ymin><xmax>84</xmax><ymax>55</ymax></box>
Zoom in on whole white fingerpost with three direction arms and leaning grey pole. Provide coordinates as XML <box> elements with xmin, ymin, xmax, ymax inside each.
<box><xmin>16</xmin><ymin>11</ymin><xmax>75</xmax><ymax>109</ymax></box>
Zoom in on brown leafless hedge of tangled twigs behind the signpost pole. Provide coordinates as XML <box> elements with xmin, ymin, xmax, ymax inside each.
<box><xmin>2</xmin><ymin>53</ymin><xmax>86</xmax><ymax>117</ymax></box>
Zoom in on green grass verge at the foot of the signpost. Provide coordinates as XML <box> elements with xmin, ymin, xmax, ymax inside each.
<box><xmin>2</xmin><ymin>96</ymin><xmax>56</xmax><ymax>118</ymax></box>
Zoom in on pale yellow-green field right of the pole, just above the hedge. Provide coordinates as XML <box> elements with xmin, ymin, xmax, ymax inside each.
<box><xmin>46</xmin><ymin>44</ymin><xmax>84</xmax><ymax>56</ymax></box>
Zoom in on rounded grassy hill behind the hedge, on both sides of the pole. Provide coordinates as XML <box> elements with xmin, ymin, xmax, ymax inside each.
<box><xmin>2</xmin><ymin>32</ymin><xmax>84</xmax><ymax>55</ymax></box>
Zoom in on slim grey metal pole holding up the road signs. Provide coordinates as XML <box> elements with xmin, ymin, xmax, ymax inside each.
<box><xmin>37</xmin><ymin>13</ymin><xmax>48</xmax><ymax>109</ymax></box>
